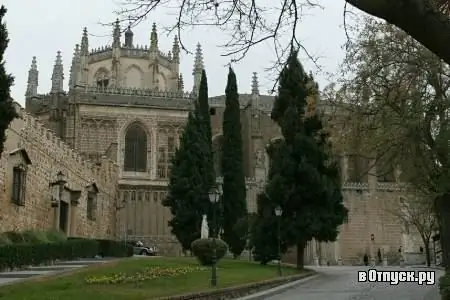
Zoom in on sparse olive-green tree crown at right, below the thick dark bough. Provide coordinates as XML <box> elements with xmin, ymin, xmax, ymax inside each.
<box><xmin>329</xmin><ymin>18</ymin><xmax>450</xmax><ymax>270</ymax></box>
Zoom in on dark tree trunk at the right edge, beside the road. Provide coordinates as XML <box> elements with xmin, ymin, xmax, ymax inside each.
<box><xmin>436</xmin><ymin>192</ymin><xmax>450</xmax><ymax>274</ymax></box>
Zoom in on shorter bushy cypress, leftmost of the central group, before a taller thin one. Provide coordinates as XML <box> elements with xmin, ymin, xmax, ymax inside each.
<box><xmin>163</xmin><ymin>102</ymin><xmax>210</xmax><ymax>251</ymax></box>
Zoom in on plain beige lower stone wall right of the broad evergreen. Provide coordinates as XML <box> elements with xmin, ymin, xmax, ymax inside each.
<box><xmin>283</xmin><ymin>183</ymin><xmax>421</xmax><ymax>265</ymax></box>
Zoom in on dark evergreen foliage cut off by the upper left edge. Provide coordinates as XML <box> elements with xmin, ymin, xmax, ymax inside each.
<box><xmin>0</xmin><ymin>5</ymin><xmax>17</xmax><ymax>156</ymax></box>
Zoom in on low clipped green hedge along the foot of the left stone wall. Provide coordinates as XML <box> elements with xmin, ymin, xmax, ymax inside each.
<box><xmin>0</xmin><ymin>239</ymin><xmax>98</xmax><ymax>271</ymax></box>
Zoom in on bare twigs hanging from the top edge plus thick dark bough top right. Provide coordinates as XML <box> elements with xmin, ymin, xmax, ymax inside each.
<box><xmin>114</xmin><ymin>0</ymin><xmax>450</xmax><ymax>69</ymax></box>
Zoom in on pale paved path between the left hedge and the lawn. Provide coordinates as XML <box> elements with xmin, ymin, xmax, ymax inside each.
<box><xmin>0</xmin><ymin>259</ymin><xmax>109</xmax><ymax>286</ymax></box>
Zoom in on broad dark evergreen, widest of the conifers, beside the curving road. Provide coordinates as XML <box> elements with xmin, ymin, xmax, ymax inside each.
<box><xmin>254</xmin><ymin>52</ymin><xmax>347</xmax><ymax>268</ymax></box>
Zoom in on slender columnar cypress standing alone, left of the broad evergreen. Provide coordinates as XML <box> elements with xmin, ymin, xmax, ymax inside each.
<box><xmin>222</xmin><ymin>68</ymin><xmax>247</xmax><ymax>257</ymax></box>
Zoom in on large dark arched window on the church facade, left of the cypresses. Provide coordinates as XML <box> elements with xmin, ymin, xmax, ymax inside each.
<box><xmin>124</xmin><ymin>123</ymin><xmax>147</xmax><ymax>172</ymax></box>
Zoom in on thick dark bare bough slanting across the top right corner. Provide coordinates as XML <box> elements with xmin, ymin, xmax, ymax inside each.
<box><xmin>346</xmin><ymin>0</ymin><xmax>450</xmax><ymax>64</ymax></box>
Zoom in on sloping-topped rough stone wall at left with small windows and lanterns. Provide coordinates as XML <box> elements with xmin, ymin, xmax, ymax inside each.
<box><xmin>0</xmin><ymin>104</ymin><xmax>117</xmax><ymax>237</ymax></box>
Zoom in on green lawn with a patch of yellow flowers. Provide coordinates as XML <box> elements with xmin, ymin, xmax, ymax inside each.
<box><xmin>0</xmin><ymin>257</ymin><xmax>308</xmax><ymax>300</ymax></box>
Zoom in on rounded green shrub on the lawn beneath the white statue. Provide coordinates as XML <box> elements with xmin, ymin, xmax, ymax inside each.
<box><xmin>191</xmin><ymin>238</ymin><xmax>228</xmax><ymax>266</ymax></box>
